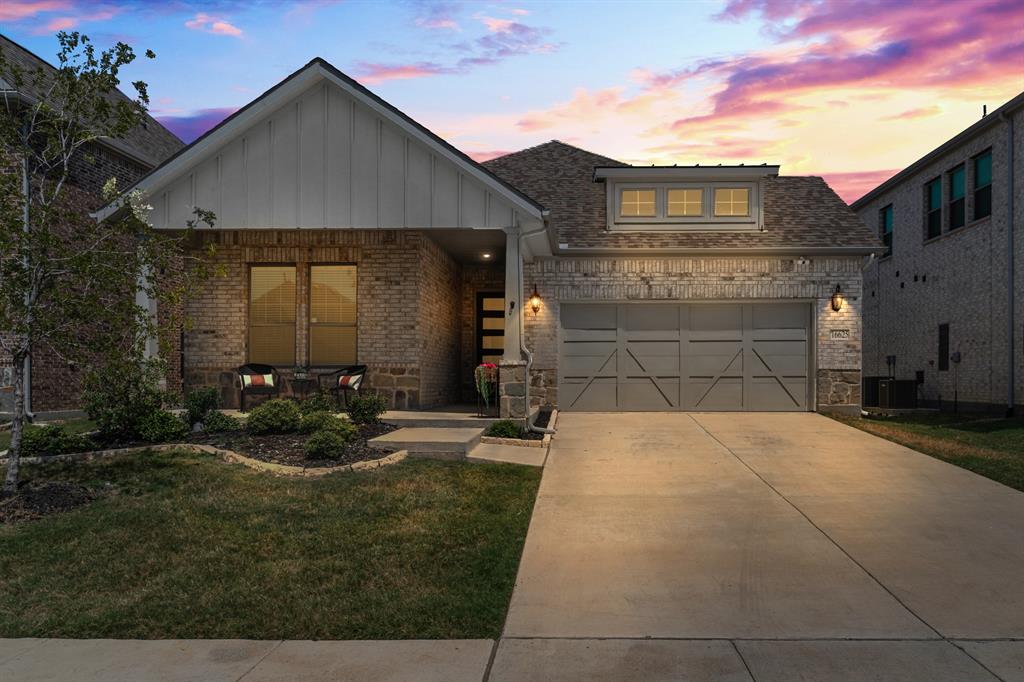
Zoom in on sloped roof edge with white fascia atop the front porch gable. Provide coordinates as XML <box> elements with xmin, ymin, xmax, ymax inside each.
<box><xmin>97</xmin><ymin>57</ymin><xmax>546</xmax><ymax>220</ymax></box>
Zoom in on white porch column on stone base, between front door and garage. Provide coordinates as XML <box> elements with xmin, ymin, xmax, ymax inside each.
<box><xmin>498</xmin><ymin>227</ymin><xmax>526</xmax><ymax>419</ymax></box>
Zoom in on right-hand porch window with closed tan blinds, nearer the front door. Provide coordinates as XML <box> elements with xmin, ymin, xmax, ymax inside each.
<box><xmin>309</xmin><ymin>265</ymin><xmax>356</xmax><ymax>367</ymax></box>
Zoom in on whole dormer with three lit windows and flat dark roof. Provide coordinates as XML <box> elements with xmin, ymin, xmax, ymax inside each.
<box><xmin>594</xmin><ymin>166</ymin><xmax>778</xmax><ymax>231</ymax></box>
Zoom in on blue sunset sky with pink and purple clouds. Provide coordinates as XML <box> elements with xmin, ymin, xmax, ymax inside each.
<box><xmin>0</xmin><ymin>0</ymin><xmax>1024</xmax><ymax>201</ymax></box>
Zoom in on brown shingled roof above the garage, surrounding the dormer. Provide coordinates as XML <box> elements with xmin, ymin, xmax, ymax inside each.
<box><xmin>484</xmin><ymin>140</ymin><xmax>881</xmax><ymax>253</ymax></box>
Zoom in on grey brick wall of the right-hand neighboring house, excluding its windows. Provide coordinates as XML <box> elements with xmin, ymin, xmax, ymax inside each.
<box><xmin>854</xmin><ymin>103</ymin><xmax>1024</xmax><ymax>413</ymax></box>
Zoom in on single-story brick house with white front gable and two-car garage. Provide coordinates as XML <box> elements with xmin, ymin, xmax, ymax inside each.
<box><xmin>90</xmin><ymin>58</ymin><xmax>881</xmax><ymax>416</ymax></box>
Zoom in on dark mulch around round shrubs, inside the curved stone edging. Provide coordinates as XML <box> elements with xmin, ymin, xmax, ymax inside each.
<box><xmin>187</xmin><ymin>422</ymin><xmax>398</xmax><ymax>468</ymax></box>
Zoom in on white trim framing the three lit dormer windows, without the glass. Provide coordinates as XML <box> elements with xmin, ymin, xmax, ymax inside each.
<box><xmin>605</xmin><ymin>179</ymin><xmax>762</xmax><ymax>231</ymax></box>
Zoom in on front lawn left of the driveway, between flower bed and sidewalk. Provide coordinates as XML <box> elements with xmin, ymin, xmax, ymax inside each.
<box><xmin>0</xmin><ymin>453</ymin><xmax>540</xmax><ymax>639</ymax></box>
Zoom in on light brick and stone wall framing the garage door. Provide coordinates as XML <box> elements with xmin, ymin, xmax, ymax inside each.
<box><xmin>502</xmin><ymin>257</ymin><xmax>861</xmax><ymax>414</ymax></box>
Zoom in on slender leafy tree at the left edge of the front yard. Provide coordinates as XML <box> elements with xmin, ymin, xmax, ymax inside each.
<box><xmin>0</xmin><ymin>32</ymin><xmax>214</xmax><ymax>494</ymax></box>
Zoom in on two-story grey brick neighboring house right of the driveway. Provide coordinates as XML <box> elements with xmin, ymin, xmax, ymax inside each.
<box><xmin>853</xmin><ymin>93</ymin><xmax>1024</xmax><ymax>413</ymax></box>
